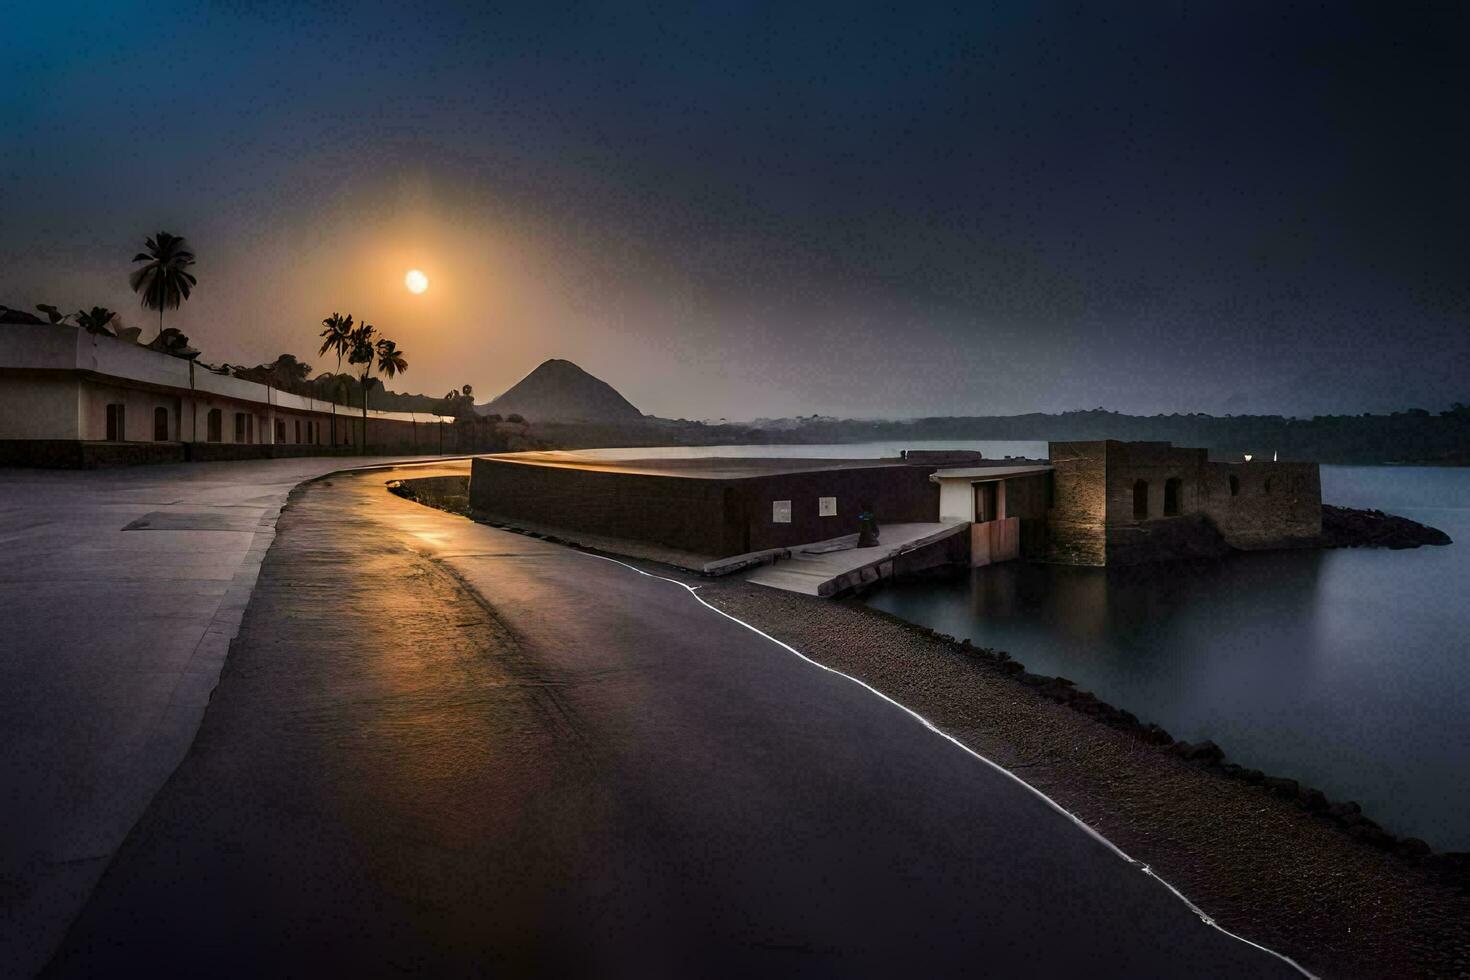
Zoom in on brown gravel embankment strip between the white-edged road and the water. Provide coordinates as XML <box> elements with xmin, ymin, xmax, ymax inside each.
<box><xmin>701</xmin><ymin>582</ymin><xmax>1470</xmax><ymax>977</ymax></box>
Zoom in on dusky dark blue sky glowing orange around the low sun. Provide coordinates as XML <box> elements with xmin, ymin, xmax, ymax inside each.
<box><xmin>0</xmin><ymin>3</ymin><xmax>1470</xmax><ymax>417</ymax></box>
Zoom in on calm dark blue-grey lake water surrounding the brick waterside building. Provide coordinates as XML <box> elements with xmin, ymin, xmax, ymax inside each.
<box><xmin>598</xmin><ymin>442</ymin><xmax>1470</xmax><ymax>849</ymax></box>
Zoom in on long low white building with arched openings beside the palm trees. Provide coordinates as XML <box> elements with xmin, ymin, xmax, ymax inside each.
<box><xmin>0</xmin><ymin>323</ymin><xmax>454</xmax><ymax>466</ymax></box>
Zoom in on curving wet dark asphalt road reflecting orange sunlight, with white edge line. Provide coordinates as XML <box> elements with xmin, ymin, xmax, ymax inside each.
<box><xmin>40</xmin><ymin>473</ymin><xmax>1295</xmax><ymax>977</ymax></box>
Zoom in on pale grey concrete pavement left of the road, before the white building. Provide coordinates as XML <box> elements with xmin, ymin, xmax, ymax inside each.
<box><xmin>0</xmin><ymin>457</ymin><xmax>464</xmax><ymax>976</ymax></box>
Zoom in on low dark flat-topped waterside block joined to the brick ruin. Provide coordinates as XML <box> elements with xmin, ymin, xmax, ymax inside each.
<box><xmin>470</xmin><ymin>439</ymin><xmax>1322</xmax><ymax>566</ymax></box>
